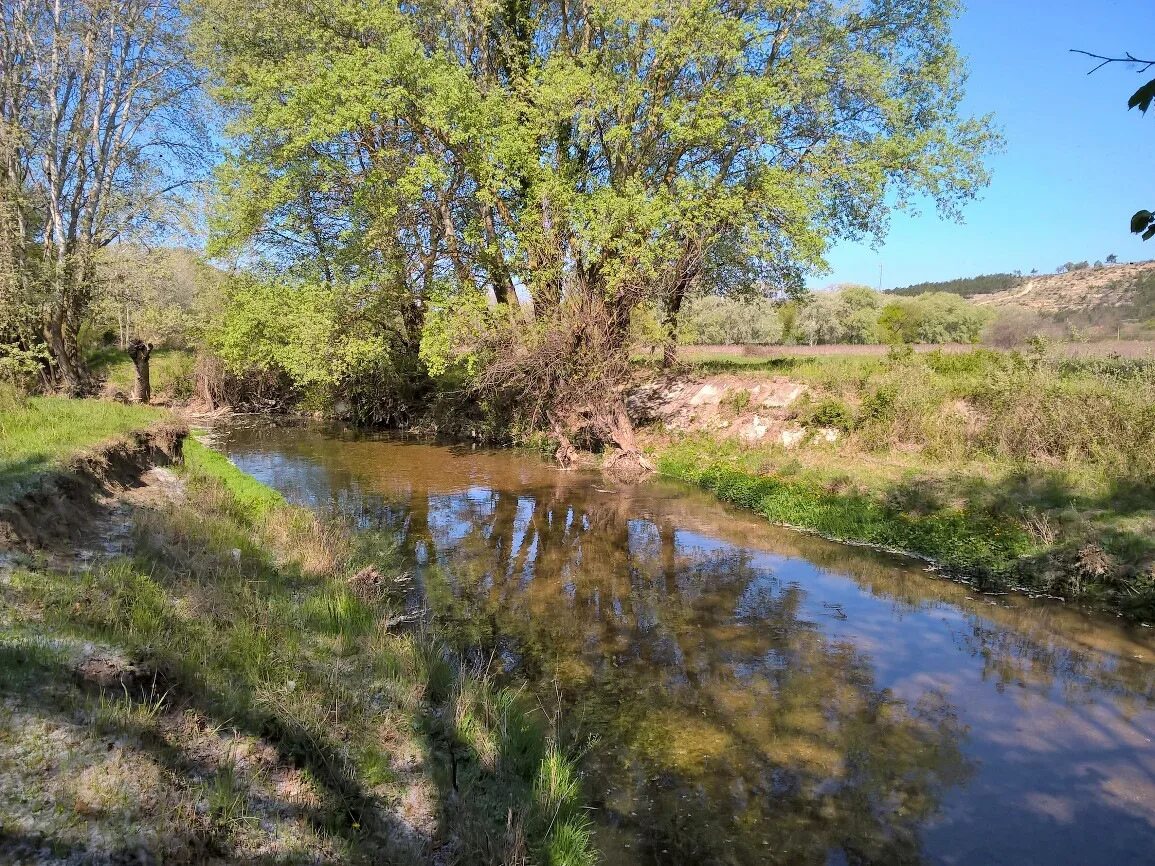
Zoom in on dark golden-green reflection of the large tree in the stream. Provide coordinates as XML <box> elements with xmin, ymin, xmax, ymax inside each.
<box><xmin>413</xmin><ymin>487</ymin><xmax>966</xmax><ymax>863</ymax></box>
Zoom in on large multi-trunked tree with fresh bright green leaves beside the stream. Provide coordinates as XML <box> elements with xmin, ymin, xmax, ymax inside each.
<box><xmin>200</xmin><ymin>0</ymin><xmax>994</xmax><ymax>471</ymax></box>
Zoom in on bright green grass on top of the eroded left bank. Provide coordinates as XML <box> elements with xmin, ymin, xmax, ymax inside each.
<box><xmin>0</xmin><ymin>393</ymin><xmax>166</xmax><ymax>501</ymax></box>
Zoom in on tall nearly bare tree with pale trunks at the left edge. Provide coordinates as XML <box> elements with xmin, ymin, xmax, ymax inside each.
<box><xmin>0</xmin><ymin>0</ymin><xmax>202</xmax><ymax>391</ymax></box>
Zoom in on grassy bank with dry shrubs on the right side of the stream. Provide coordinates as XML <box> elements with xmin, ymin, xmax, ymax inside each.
<box><xmin>651</xmin><ymin>350</ymin><xmax>1155</xmax><ymax>619</ymax></box>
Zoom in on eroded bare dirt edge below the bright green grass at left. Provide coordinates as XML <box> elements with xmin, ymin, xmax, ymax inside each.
<box><xmin>0</xmin><ymin>423</ymin><xmax>188</xmax><ymax>551</ymax></box>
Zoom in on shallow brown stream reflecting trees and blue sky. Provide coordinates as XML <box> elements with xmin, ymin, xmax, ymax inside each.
<box><xmin>214</xmin><ymin>427</ymin><xmax>1155</xmax><ymax>864</ymax></box>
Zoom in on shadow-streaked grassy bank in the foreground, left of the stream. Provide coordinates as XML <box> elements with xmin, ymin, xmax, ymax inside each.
<box><xmin>0</xmin><ymin>427</ymin><xmax>593</xmax><ymax>864</ymax></box>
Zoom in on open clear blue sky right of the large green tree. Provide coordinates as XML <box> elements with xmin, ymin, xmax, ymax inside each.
<box><xmin>811</xmin><ymin>0</ymin><xmax>1155</xmax><ymax>289</ymax></box>
